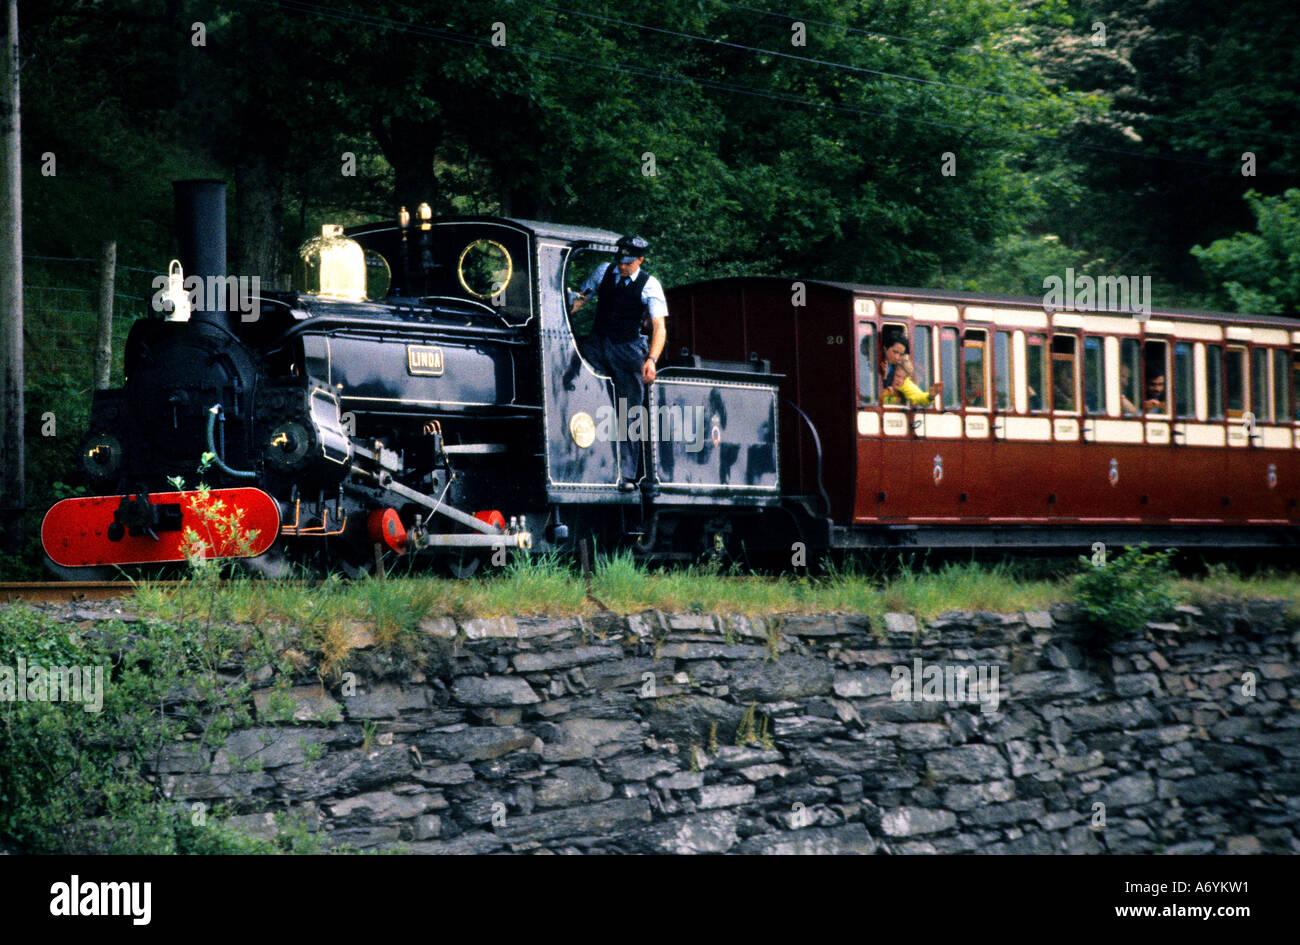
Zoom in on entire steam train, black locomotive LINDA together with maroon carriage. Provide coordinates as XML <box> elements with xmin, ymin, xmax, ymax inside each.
<box><xmin>43</xmin><ymin>181</ymin><xmax>1300</xmax><ymax>575</ymax></box>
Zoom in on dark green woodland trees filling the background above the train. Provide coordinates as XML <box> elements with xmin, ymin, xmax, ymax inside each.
<box><xmin>22</xmin><ymin>0</ymin><xmax>1300</xmax><ymax>296</ymax></box>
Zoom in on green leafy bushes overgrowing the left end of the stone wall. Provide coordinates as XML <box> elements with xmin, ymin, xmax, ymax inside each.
<box><xmin>0</xmin><ymin>607</ymin><xmax>325</xmax><ymax>854</ymax></box>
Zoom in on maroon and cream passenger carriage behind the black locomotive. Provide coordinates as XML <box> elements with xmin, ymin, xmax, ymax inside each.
<box><xmin>667</xmin><ymin>278</ymin><xmax>1300</xmax><ymax>547</ymax></box>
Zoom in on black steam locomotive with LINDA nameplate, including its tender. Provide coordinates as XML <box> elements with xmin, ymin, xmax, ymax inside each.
<box><xmin>47</xmin><ymin>181</ymin><xmax>781</xmax><ymax>567</ymax></box>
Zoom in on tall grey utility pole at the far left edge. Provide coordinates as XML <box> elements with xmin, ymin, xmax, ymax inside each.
<box><xmin>0</xmin><ymin>0</ymin><xmax>27</xmax><ymax>552</ymax></box>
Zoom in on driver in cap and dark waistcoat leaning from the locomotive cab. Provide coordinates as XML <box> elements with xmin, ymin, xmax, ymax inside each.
<box><xmin>569</xmin><ymin>237</ymin><xmax>668</xmax><ymax>493</ymax></box>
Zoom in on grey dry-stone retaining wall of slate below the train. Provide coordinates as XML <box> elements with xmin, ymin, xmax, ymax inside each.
<box><xmin>156</xmin><ymin>602</ymin><xmax>1300</xmax><ymax>853</ymax></box>
